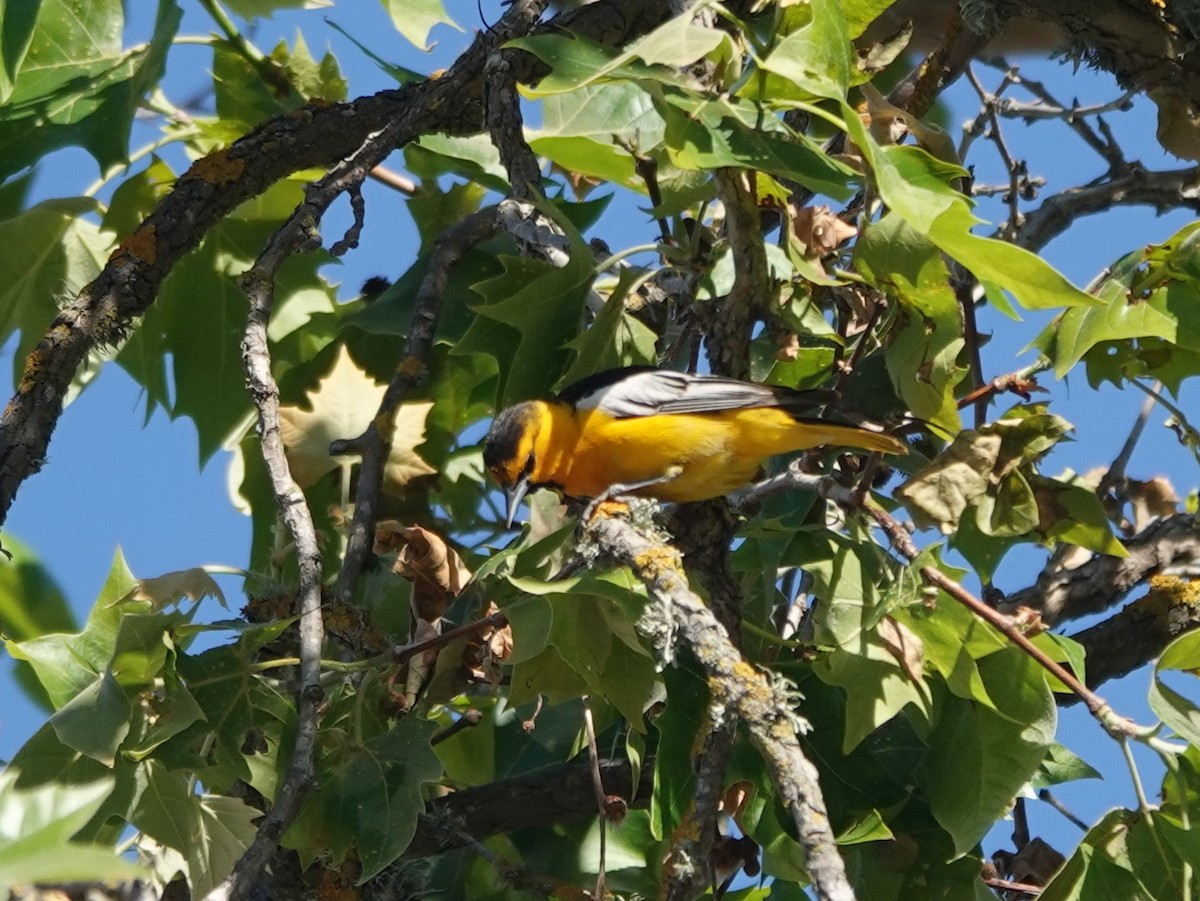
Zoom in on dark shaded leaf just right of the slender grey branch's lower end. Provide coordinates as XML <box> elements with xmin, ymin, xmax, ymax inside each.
<box><xmin>296</xmin><ymin>716</ymin><xmax>442</xmax><ymax>884</ymax></box>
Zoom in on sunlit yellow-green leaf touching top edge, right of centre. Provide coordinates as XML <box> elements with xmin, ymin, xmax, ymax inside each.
<box><xmin>760</xmin><ymin>0</ymin><xmax>854</xmax><ymax>100</ymax></box>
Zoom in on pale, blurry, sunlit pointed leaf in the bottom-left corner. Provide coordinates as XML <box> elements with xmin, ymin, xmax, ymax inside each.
<box><xmin>0</xmin><ymin>769</ymin><xmax>144</xmax><ymax>885</ymax></box>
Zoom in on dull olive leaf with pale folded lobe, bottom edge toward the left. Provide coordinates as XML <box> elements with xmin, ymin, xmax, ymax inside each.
<box><xmin>131</xmin><ymin>761</ymin><xmax>262</xmax><ymax>897</ymax></box>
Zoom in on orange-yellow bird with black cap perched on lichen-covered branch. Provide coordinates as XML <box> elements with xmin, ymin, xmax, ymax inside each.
<box><xmin>484</xmin><ymin>366</ymin><xmax>908</xmax><ymax>524</ymax></box>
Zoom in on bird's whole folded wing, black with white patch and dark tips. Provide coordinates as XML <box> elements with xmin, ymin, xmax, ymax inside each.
<box><xmin>559</xmin><ymin>366</ymin><xmax>833</xmax><ymax>419</ymax></box>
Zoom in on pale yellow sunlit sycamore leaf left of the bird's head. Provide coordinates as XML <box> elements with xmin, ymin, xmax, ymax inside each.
<box><xmin>280</xmin><ymin>347</ymin><xmax>437</xmax><ymax>488</ymax></box>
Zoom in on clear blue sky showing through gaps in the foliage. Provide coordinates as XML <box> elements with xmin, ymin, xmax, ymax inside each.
<box><xmin>0</xmin><ymin>0</ymin><xmax>1200</xmax><ymax>873</ymax></box>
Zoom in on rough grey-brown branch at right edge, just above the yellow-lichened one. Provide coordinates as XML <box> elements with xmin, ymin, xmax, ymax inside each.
<box><xmin>1000</xmin><ymin>513</ymin><xmax>1200</xmax><ymax>626</ymax></box>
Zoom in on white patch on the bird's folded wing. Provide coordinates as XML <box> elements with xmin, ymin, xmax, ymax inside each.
<box><xmin>575</xmin><ymin>370</ymin><xmax>782</xmax><ymax>419</ymax></box>
